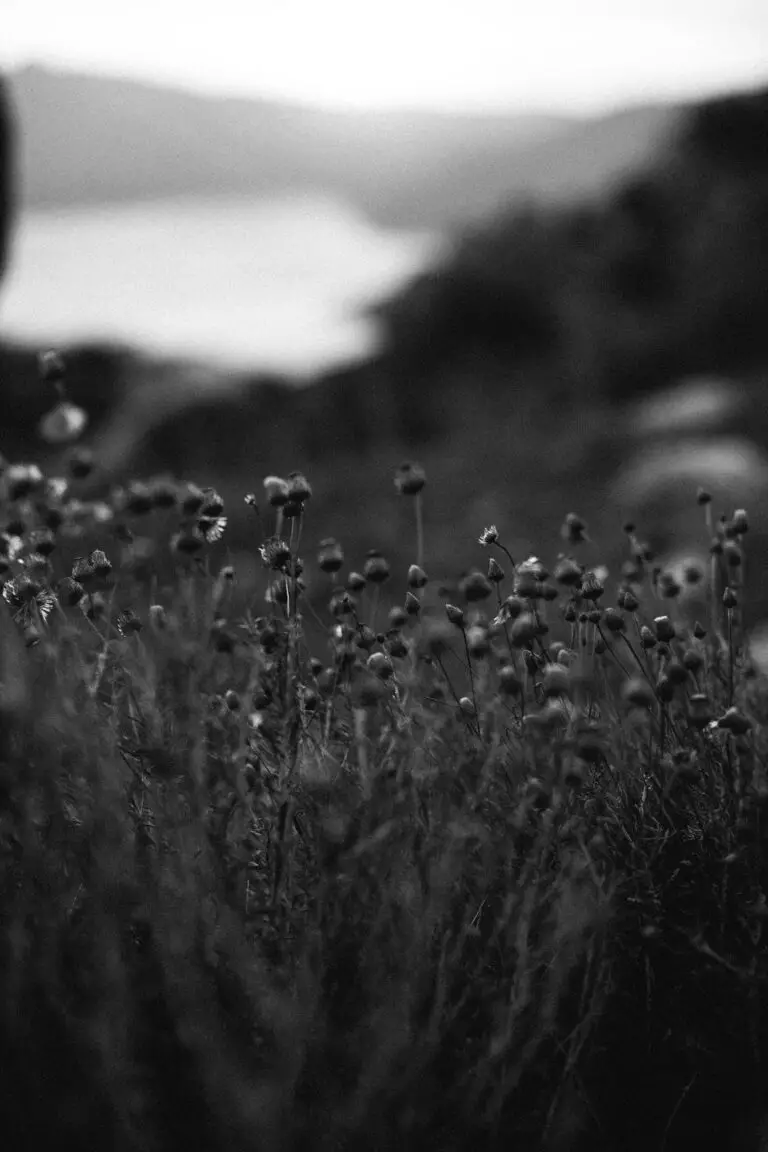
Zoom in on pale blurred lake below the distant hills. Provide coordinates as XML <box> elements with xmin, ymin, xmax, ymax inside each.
<box><xmin>0</xmin><ymin>196</ymin><xmax>442</xmax><ymax>374</ymax></box>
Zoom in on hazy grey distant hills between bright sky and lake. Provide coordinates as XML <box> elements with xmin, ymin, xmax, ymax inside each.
<box><xmin>4</xmin><ymin>66</ymin><xmax>680</xmax><ymax>229</ymax></box>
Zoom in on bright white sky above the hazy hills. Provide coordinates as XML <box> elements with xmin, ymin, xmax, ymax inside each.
<box><xmin>0</xmin><ymin>0</ymin><xmax>768</xmax><ymax>114</ymax></box>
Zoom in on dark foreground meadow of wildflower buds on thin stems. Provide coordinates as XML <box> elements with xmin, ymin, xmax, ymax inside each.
<box><xmin>0</xmin><ymin>354</ymin><xmax>768</xmax><ymax>1152</ymax></box>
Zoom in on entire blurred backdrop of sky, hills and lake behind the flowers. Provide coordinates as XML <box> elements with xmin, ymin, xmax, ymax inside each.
<box><xmin>0</xmin><ymin>0</ymin><xmax>768</xmax><ymax>645</ymax></box>
